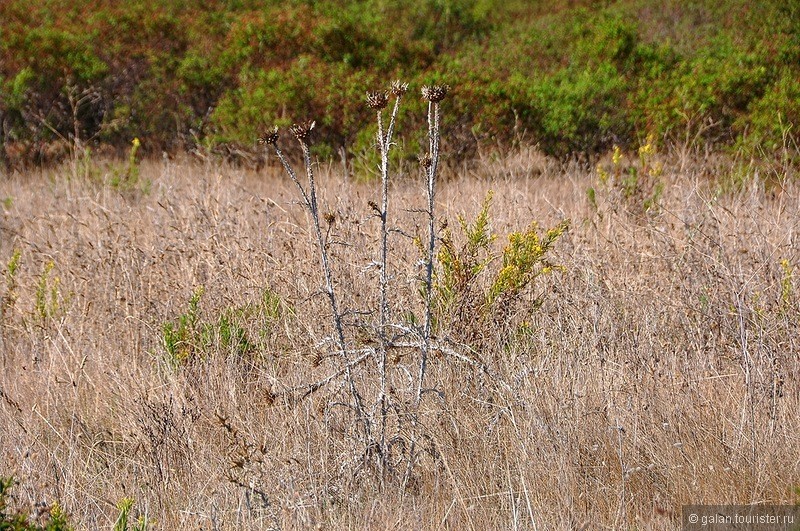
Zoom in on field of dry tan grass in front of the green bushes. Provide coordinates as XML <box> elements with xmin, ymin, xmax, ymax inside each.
<box><xmin>0</xmin><ymin>152</ymin><xmax>800</xmax><ymax>530</ymax></box>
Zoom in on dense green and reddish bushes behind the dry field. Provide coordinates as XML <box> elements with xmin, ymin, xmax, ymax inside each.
<box><xmin>0</xmin><ymin>0</ymin><xmax>800</xmax><ymax>166</ymax></box>
